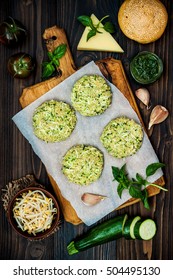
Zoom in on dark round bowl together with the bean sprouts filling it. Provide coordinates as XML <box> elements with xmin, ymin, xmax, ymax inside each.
<box><xmin>8</xmin><ymin>186</ymin><xmax>60</xmax><ymax>240</ymax></box>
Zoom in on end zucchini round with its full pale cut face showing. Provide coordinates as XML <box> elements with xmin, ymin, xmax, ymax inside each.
<box><xmin>134</xmin><ymin>219</ymin><xmax>157</xmax><ymax>240</ymax></box>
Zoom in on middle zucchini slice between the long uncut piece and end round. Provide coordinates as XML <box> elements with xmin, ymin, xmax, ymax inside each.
<box><xmin>123</xmin><ymin>216</ymin><xmax>141</xmax><ymax>239</ymax></box>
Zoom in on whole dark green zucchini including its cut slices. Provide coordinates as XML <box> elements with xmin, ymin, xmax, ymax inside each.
<box><xmin>67</xmin><ymin>214</ymin><xmax>156</xmax><ymax>255</ymax></box>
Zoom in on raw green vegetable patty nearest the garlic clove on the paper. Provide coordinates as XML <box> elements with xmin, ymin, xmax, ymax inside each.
<box><xmin>62</xmin><ymin>145</ymin><xmax>103</xmax><ymax>186</ymax></box>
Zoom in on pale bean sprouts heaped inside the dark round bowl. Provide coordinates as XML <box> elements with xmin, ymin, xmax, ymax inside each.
<box><xmin>13</xmin><ymin>190</ymin><xmax>57</xmax><ymax>235</ymax></box>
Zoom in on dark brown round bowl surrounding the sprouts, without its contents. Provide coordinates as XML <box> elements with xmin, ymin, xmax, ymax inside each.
<box><xmin>8</xmin><ymin>186</ymin><xmax>60</xmax><ymax>240</ymax></box>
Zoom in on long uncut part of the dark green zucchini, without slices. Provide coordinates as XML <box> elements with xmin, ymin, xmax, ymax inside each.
<box><xmin>67</xmin><ymin>214</ymin><xmax>127</xmax><ymax>255</ymax></box>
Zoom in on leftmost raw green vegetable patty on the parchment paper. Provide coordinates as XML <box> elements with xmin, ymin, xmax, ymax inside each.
<box><xmin>33</xmin><ymin>100</ymin><xmax>77</xmax><ymax>142</ymax></box>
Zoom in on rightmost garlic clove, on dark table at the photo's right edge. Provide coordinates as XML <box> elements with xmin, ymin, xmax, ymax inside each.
<box><xmin>148</xmin><ymin>105</ymin><xmax>169</xmax><ymax>129</ymax></box>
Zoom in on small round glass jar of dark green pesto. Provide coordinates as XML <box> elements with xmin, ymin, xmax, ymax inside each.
<box><xmin>130</xmin><ymin>51</ymin><xmax>163</xmax><ymax>84</ymax></box>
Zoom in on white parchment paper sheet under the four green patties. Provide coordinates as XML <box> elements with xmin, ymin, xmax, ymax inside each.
<box><xmin>13</xmin><ymin>62</ymin><xmax>163</xmax><ymax>226</ymax></box>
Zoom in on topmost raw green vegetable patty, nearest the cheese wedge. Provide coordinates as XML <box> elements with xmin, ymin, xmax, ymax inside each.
<box><xmin>71</xmin><ymin>75</ymin><xmax>112</xmax><ymax>116</ymax></box>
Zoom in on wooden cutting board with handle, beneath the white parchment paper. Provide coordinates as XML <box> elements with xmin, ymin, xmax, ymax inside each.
<box><xmin>19</xmin><ymin>26</ymin><xmax>165</xmax><ymax>225</ymax></box>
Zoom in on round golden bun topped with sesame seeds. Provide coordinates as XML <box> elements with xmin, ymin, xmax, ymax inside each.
<box><xmin>118</xmin><ymin>0</ymin><xmax>168</xmax><ymax>44</ymax></box>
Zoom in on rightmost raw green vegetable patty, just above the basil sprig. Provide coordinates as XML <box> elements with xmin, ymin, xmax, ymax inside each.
<box><xmin>100</xmin><ymin>117</ymin><xmax>143</xmax><ymax>158</ymax></box>
